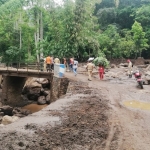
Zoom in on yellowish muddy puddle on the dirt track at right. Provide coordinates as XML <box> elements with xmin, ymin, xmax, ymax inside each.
<box><xmin>123</xmin><ymin>100</ymin><xmax>150</xmax><ymax>111</ymax></box>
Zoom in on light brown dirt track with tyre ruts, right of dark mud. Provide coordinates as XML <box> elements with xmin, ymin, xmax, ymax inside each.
<box><xmin>66</xmin><ymin>73</ymin><xmax>150</xmax><ymax>150</ymax></box>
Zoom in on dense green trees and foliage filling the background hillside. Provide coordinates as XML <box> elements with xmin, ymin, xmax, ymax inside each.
<box><xmin>0</xmin><ymin>0</ymin><xmax>150</xmax><ymax>62</ymax></box>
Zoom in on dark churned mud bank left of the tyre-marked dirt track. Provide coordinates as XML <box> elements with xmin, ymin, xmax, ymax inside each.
<box><xmin>0</xmin><ymin>81</ymin><xmax>110</xmax><ymax>150</ymax></box>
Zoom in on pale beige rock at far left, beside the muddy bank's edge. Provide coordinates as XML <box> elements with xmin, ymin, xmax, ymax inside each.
<box><xmin>2</xmin><ymin>115</ymin><xmax>19</xmax><ymax>125</ymax></box>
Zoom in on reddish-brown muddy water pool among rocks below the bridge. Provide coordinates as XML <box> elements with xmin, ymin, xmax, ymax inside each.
<box><xmin>22</xmin><ymin>104</ymin><xmax>48</xmax><ymax>113</ymax></box>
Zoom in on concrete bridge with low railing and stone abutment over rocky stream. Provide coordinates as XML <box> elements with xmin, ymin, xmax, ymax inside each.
<box><xmin>0</xmin><ymin>67</ymin><xmax>69</xmax><ymax>107</ymax></box>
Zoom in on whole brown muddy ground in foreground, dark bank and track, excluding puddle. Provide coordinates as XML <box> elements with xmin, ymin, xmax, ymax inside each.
<box><xmin>0</xmin><ymin>68</ymin><xmax>150</xmax><ymax>150</ymax></box>
